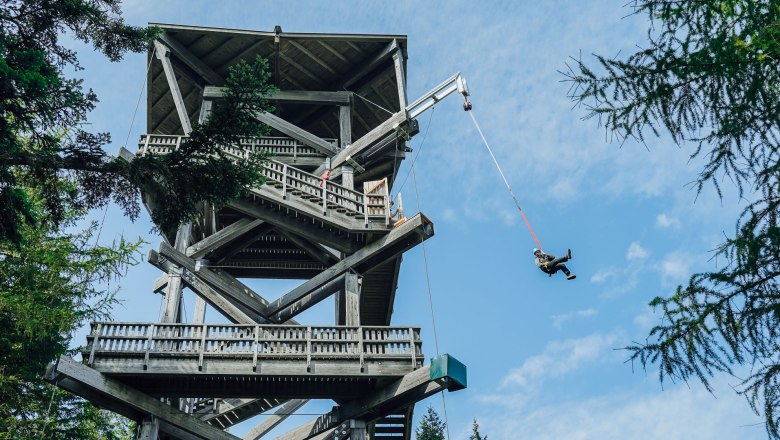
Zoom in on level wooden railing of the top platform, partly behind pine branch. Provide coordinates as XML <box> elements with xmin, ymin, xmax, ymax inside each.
<box><xmin>138</xmin><ymin>134</ymin><xmax>336</xmax><ymax>161</ymax></box>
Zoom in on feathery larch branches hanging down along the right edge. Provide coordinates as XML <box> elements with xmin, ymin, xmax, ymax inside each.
<box><xmin>564</xmin><ymin>0</ymin><xmax>780</xmax><ymax>438</ymax></box>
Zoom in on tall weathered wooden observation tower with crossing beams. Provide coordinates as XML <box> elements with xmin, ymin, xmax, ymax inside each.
<box><xmin>47</xmin><ymin>25</ymin><xmax>468</xmax><ymax>440</ymax></box>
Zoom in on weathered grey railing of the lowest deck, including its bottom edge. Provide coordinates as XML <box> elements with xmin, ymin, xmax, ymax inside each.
<box><xmin>84</xmin><ymin>322</ymin><xmax>423</xmax><ymax>380</ymax></box>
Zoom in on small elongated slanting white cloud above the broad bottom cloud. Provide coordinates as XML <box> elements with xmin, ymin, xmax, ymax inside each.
<box><xmin>501</xmin><ymin>333</ymin><xmax>617</xmax><ymax>388</ymax></box>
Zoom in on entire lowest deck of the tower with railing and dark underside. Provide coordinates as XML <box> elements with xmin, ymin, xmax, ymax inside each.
<box><xmin>82</xmin><ymin>322</ymin><xmax>424</xmax><ymax>398</ymax></box>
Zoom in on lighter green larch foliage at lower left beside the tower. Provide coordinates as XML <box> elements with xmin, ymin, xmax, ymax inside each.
<box><xmin>0</xmin><ymin>187</ymin><xmax>140</xmax><ymax>439</ymax></box>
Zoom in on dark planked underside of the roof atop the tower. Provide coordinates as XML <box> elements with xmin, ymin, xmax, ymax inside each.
<box><xmin>147</xmin><ymin>23</ymin><xmax>406</xmax><ymax>139</ymax></box>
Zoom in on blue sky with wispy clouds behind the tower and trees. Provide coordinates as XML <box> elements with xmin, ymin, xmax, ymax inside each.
<box><xmin>68</xmin><ymin>0</ymin><xmax>765</xmax><ymax>440</ymax></box>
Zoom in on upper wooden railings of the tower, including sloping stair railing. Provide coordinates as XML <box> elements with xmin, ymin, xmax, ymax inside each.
<box><xmin>138</xmin><ymin>135</ymin><xmax>390</xmax><ymax>227</ymax></box>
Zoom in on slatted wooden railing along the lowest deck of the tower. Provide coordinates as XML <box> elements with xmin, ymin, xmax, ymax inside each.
<box><xmin>84</xmin><ymin>322</ymin><xmax>423</xmax><ymax>368</ymax></box>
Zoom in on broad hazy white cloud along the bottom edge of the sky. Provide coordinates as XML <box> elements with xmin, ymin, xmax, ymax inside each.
<box><xmin>478</xmin><ymin>381</ymin><xmax>766</xmax><ymax>440</ymax></box>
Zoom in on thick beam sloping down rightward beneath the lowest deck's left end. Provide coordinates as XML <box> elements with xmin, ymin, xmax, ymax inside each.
<box><xmin>45</xmin><ymin>357</ymin><xmax>240</xmax><ymax>440</ymax></box>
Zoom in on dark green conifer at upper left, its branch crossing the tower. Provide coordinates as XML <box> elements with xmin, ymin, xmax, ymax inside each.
<box><xmin>0</xmin><ymin>0</ymin><xmax>273</xmax><ymax>242</ymax></box>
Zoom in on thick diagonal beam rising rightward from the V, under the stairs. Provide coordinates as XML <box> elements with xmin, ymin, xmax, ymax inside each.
<box><xmin>267</xmin><ymin>214</ymin><xmax>433</xmax><ymax>316</ymax></box>
